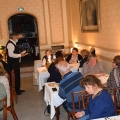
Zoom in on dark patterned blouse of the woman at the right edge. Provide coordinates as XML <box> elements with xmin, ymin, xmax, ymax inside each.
<box><xmin>107</xmin><ymin>67</ymin><xmax>120</xmax><ymax>106</ymax></box>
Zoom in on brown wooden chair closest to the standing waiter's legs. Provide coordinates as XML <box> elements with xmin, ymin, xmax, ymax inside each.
<box><xmin>7</xmin><ymin>70</ymin><xmax>18</xmax><ymax>120</ymax></box>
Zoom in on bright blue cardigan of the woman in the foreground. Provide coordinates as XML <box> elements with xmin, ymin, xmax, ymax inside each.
<box><xmin>85</xmin><ymin>90</ymin><xmax>115</xmax><ymax>120</ymax></box>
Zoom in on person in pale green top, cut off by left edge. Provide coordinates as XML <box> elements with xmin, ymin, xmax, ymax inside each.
<box><xmin>0</xmin><ymin>83</ymin><xmax>6</xmax><ymax>120</ymax></box>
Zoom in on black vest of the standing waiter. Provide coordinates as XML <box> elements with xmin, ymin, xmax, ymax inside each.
<box><xmin>6</xmin><ymin>40</ymin><xmax>19</xmax><ymax>66</ymax></box>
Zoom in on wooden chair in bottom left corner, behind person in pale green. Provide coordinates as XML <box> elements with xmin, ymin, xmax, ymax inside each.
<box><xmin>0</xmin><ymin>96</ymin><xmax>7</xmax><ymax>120</ymax></box>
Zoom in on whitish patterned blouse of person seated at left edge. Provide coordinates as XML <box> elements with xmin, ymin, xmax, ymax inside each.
<box><xmin>0</xmin><ymin>76</ymin><xmax>10</xmax><ymax>107</ymax></box>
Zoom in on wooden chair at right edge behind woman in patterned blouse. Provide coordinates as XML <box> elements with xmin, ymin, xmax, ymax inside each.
<box><xmin>114</xmin><ymin>88</ymin><xmax>120</xmax><ymax>115</ymax></box>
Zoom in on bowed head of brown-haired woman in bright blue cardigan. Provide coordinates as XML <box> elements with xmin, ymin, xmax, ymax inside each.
<box><xmin>80</xmin><ymin>75</ymin><xmax>103</xmax><ymax>94</ymax></box>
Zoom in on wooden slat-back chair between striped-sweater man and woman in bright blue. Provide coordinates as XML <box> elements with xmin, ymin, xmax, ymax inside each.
<box><xmin>68</xmin><ymin>90</ymin><xmax>89</xmax><ymax>120</ymax></box>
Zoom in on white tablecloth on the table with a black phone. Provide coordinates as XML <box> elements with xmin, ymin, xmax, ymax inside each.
<box><xmin>44</xmin><ymin>83</ymin><xmax>64</xmax><ymax>119</ymax></box>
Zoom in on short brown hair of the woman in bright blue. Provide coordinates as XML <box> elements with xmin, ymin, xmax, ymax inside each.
<box><xmin>80</xmin><ymin>75</ymin><xmax>104</xmax><ymax>88</ymax></box>
